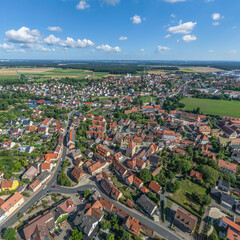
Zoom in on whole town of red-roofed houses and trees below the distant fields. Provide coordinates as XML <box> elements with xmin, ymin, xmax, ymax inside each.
<box><xmin>0</xmin><ymin>66</ymin><xmax>240</xmax><ymax>240</ymax></box>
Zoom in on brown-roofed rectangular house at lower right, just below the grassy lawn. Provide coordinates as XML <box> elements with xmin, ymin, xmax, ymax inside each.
<box><xmin>174</xmin><ymin>207</ymin><xmax>198</xmax><ymax>233</ymax></box>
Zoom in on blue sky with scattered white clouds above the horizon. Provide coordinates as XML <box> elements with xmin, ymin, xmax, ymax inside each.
<box><xmin>0</xmin><ymin>0</ymin><xmax>240</xmax><ymax>60</ymax></box>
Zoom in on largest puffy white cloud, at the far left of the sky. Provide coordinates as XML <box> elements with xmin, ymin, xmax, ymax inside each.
<box><xmin>5</xmin><ymin>27</ymin><xmax>41</xmax><ymax>43</ymax></box>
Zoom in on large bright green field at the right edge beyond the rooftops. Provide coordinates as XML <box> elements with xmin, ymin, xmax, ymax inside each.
<box><xmin>181</xmin><ymin>98</ymin><xmax>240</xmax><ymax>117</ymax></box>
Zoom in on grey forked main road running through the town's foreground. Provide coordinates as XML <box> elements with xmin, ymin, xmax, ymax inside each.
<box><xmin>0</xmin><ymin>112</ymin><xmax>181</xmax><ymax>240</ymax></box>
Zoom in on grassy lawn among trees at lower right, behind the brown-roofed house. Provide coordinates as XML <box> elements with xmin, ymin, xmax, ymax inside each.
<box><xmin>173</xmin><ymin>180</ymin><xmax>206</xmax><ymax>212</ymax></box>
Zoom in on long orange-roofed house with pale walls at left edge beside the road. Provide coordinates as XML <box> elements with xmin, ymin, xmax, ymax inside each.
<box><xmin>0</xmin><ymin>192</ymin><xmax>24</xmax><ymax>223</ymax></box>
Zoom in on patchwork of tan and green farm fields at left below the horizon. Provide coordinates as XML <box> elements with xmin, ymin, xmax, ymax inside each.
<box><xmin>0</xmin><ymin>68</ymin><xmax>108</xmax><ymax>81</ymax></box>
